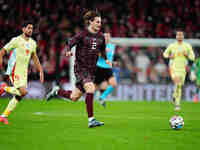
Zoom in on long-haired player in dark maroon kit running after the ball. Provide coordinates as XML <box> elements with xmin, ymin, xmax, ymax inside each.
<box><xmin>47</xmin><ymin>11</ymin><xmax>112</xmax><ymax>128</ymax></box>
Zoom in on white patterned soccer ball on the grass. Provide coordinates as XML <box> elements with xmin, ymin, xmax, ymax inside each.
<box><xmin>169</xmin><ymin>115</ymin><xmax>184</xmax><ymax>130</ymax></box>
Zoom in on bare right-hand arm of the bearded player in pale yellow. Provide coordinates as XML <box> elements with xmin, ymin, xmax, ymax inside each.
<box><xmin>32</xmin><ymin>52</ymin><xmax>44</xmax><ymax>83</ymax></box>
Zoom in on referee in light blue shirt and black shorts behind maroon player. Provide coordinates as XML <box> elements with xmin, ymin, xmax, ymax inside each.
<box><xmin>95</xmin><ymin>33</ymin><xmax>117</xmax><ymax>107</ymax></box>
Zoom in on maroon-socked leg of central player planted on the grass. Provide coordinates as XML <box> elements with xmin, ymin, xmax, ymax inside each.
<box><xmin>84</xmin><ymin>82</ymin><xmax>104</xmax><ymax>128</ymax></box>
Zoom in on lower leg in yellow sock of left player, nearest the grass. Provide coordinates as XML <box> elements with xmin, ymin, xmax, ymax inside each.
<box><xmin>0</xmin><ymin>87</ymin><xmax>27</xmax><ymax>124</ymax></box>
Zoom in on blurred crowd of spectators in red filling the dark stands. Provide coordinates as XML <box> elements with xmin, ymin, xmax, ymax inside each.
<box><xmin>0</xmin><ymin>0</ymin><xmax>200</xmax><ymax>83</ymax></box>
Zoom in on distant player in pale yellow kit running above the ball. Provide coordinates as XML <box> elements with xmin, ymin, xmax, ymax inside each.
<box><xmin>163</xmin><ymin>30</ymin><xmax>195</xmax><ymax>111</ymax></box>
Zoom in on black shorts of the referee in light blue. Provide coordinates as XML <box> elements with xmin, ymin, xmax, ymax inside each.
<box><xmin>94</xmin><ymin>67</ymin><xmax>113</xmax><ymax>85</ymax></box>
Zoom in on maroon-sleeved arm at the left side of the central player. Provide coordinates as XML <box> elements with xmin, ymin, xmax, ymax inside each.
<box><xmin>65</xmin><ymin>32</ymin><xmax>83</xmax><ymax>56</ymax></box>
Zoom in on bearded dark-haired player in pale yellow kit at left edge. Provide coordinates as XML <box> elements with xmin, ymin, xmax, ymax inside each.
<box><xmin>0</xmin><ymin>21</ymin><xmax>44</xmax><ymax>124</ymax></box>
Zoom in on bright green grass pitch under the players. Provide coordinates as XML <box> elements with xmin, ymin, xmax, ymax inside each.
<box><xmin>0</xmin><ymin>99</ymin><xmax>200</xmax><ymax>150</ymax></box>
